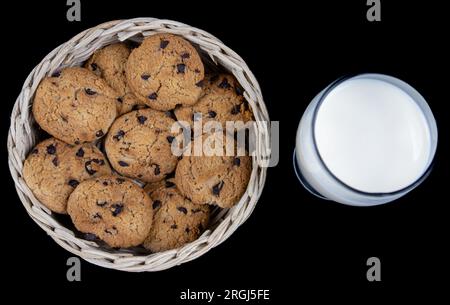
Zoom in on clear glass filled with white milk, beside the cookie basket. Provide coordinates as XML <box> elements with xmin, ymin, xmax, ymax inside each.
<box><xmin>294</xmin><ymin>74</ymin><xmax>438</xmax><ymax>206</ymax></box>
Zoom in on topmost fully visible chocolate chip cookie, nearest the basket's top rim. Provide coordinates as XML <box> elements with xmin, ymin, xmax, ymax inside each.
<box><xmin>126</xmin><ymin>34</ymin><xmax>204</xmax><ymax>111</ymax></box>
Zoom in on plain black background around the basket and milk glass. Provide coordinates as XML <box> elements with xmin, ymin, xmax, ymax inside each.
<box><xmin>1</xmin><ymin>0</ymin><xmax>450</xmax><ymax>304</ymax></box>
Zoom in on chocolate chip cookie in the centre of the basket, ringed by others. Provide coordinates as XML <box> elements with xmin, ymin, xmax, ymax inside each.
<box><xmin>105</xmin><ymin>108</ymin><xmax>178</xmax><ymax>182</ymax></box>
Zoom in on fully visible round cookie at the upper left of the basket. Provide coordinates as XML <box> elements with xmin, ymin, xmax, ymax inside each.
<box><xmin>33</xmin><ymin>67</ymin><xmax>117</xmax><ymax>144</ymax></box>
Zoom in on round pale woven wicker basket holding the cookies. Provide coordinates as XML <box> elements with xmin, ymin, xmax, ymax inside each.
<box><xmin>8</xmin><ymin>18</ymin><xmax>270</xmax><ymax>272</ymax></box>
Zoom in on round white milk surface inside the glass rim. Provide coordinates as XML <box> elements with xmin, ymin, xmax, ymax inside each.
<box><xmin>314</xmin><ymin>78</ymin><xmax>431</xmax><ymax>193</ymax></box>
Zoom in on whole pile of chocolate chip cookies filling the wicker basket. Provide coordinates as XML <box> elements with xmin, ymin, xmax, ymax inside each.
<box><xmin>23</xmin><ymin>34</ymin><xmax>252</xmax><ymax>252</ymax></box>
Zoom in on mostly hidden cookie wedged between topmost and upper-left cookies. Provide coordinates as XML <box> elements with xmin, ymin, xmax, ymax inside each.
<box><xmin>85</xmin><ymin>42</ymin><xmax>145</xmax><ymax>114</ymax></box>
